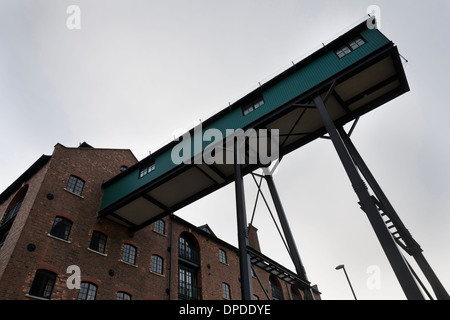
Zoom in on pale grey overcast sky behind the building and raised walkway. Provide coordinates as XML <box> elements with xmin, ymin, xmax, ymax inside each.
<box><xmin>0</xmin><ymin>0</ymin><xmax>450</xmax><ymax>299</ymax></box>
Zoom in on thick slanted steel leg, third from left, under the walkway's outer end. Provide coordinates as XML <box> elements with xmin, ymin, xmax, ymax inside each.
<box><xmin>314</xmin><ymin>95</ymin><xmax>424</xmax><ymax>300</ymax></box>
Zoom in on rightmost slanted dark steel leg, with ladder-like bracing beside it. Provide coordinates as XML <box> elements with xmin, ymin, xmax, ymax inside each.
<box><xmin>339</xmin><ymin>128</ymin><xmax>450</xmax><ymax>300</ymax></box>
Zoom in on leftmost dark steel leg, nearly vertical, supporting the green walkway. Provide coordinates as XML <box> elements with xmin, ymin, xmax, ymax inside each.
<box><xmin>234</xmin><ymin>138</ymin><xmax>253</xmax><ymax>300</ymax></box>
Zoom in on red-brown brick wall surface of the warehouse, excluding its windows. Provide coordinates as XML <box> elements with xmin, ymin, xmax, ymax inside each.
<box><xmin>0</xmin><ymin>144</ymin><xmax>320</xmax><ymax>300</ymax></box>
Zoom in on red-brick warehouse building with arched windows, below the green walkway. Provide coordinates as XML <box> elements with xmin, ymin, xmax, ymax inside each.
<box><xmin>0</xmin><ymin>143</ymin><xmax>320</xmax><ymax>300</ymax></box>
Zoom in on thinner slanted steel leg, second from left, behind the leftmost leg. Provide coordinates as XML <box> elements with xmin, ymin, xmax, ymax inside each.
<box><xmin>264</xmin><ymin>175</ymin><xmax>314</xmax><ymax>300</ymax></box>
